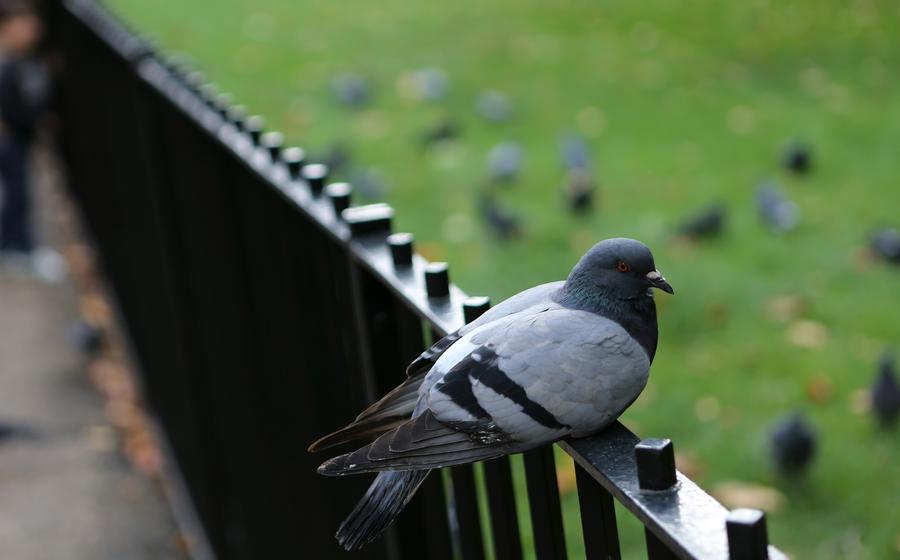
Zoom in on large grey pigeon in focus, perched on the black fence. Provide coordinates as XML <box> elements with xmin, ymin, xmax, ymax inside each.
<box><xmin>309</xmin><ymin>238</ymin><xmax>674</xmax><ymax>550</ymax></box>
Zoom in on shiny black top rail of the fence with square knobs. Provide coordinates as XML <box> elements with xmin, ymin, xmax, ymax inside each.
<box><xmin>64</xmin><ymin>0</ymin><xmax>787</xmax><ymax>559</ymax></box>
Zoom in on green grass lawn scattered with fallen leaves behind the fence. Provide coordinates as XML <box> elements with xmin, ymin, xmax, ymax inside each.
<box><xmin>105</xmin><ymin>0</ymin><xmax>900</xmax><ymax>559</ymax></box>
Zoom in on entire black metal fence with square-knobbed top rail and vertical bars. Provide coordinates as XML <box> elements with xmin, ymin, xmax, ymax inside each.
<box><xmin>48</xmin><ymin>0</ymin><xmax>783</xmax><ymax>560</ymax></box>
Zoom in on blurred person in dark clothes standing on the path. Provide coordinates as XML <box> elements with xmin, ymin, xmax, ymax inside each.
<box><xmin>0</xmin><ymin>0</ymin><xmax>49</xmax><ymax>275</ymax></box>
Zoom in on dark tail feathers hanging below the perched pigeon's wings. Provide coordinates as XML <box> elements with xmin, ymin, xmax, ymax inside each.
<box><xmin>335</xmin><ymin>470</ymin><xmax>431</xmax><ymax>550</ymax></box>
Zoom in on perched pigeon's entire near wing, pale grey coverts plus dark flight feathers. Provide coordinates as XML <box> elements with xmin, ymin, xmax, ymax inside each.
<box><xmin>319</xmin><ymin>306</ymin><xmax>650</xmax><ymax>475</ymax></box>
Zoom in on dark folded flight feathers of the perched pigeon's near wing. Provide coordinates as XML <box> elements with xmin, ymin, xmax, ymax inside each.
<box><xmin>319</xmin><ymin>411</ymin><xmax>513</xmax><ymax>476</ymax></box>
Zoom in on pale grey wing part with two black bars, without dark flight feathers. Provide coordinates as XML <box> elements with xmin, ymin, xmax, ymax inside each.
<box><xmin>428</xmin><ymin>306</ymin><xmax>650</xmax><ymax>446</ymax></box>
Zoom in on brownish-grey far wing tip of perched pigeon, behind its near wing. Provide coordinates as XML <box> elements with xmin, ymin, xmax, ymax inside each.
<box><xmin>308</xmin><ymin>373</ymin><xmax>425</xmax><ymax>451</ymax></box>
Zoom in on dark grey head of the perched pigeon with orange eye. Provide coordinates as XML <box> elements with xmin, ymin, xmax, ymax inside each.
<box><xmin>566</xmin><ymin>237</ymin><xmax>675</xmax><ymax>299</ymax></box>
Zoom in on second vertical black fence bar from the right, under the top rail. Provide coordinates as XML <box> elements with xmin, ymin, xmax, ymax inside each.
<box><xmin>575</xmin><ymin>463</ymin><xmax>622</xmax><ymax>560</ymax></box>
